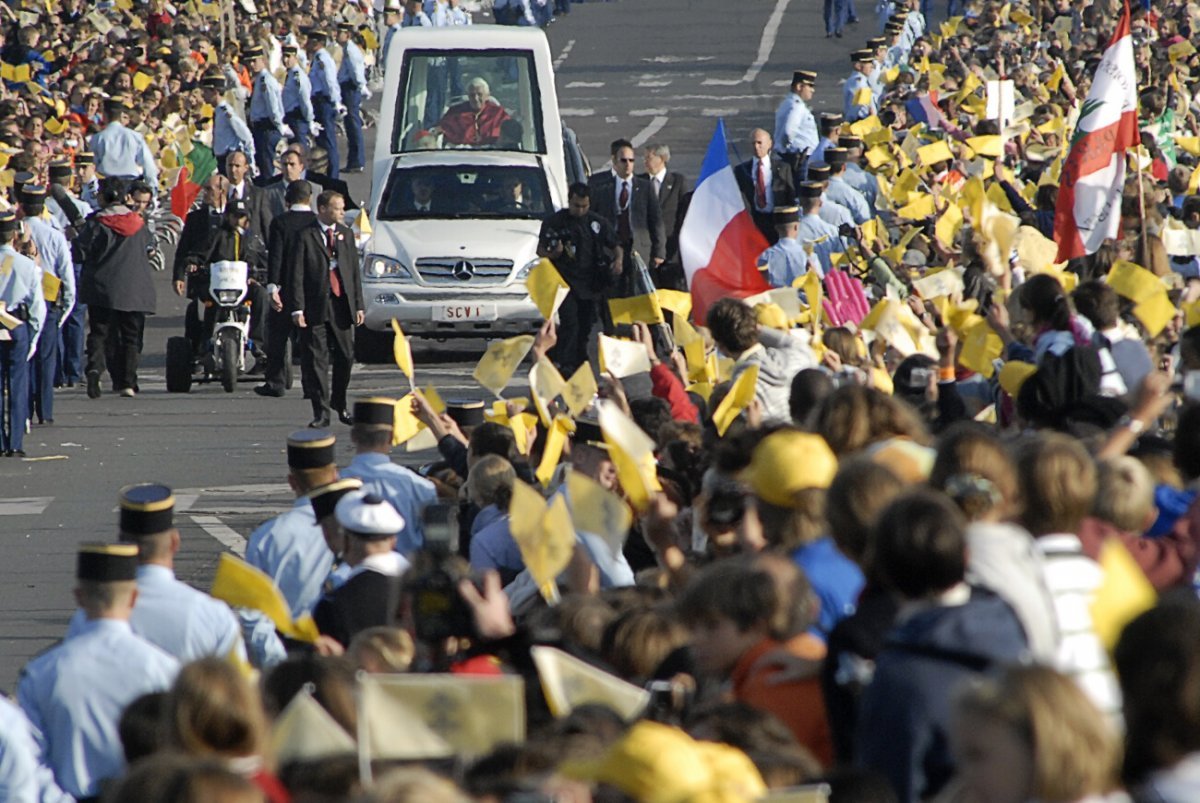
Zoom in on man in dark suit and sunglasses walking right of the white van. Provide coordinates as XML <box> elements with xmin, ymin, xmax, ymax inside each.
<box><xmin>590</xmin><ymin>139</ymin><xmax>667</xmax><ymax>298</ymax></box>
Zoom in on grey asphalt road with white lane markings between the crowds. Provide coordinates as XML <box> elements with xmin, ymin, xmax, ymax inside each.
<box><xmin>0</xmin><ymin>0</ymin><xmax>877</xmax><ymax>690</ymax></box>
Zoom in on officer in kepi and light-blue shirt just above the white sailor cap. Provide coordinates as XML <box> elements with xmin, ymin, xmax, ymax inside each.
<box><xmin>341</xmin><ymin>397</ymin><xmax>438</xmax><ymax>556</ymax></box>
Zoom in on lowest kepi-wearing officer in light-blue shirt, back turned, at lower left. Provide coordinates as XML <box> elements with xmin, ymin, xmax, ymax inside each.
<box><xmin>17</xmin><ymin>544</ymin><xmax>179</xmax><ymax>799</ymax></box>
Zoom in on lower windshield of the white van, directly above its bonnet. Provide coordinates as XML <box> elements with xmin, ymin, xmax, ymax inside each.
<box><xmin>378</xmin><ymin>164</ymin><xmax>554</xmax><ymax>221</ymax></box>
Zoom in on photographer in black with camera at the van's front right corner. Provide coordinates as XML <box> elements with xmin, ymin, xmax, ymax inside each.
<box><xmin>538</xmin><ymin>182</ymin><xmax>623</xmax><ymax>376</ymax></box>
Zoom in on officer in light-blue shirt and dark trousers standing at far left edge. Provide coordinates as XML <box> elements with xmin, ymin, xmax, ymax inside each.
<box><xmin>0</xmin><ymin>211</ymin><xmax>46</xmax><ymax>457</ymax></box>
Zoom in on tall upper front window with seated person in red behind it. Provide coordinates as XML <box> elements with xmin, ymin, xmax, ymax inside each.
<box><xmin>392</xmin><ymin>49</ymin><xmax>546</xmax><ymax>154</ymax></box>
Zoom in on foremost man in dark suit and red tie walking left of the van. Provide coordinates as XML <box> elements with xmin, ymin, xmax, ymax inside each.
<box><xmin>283</xmin><ymin>190</ymin><xmax>366</xmax><ymax>429</ymax></box>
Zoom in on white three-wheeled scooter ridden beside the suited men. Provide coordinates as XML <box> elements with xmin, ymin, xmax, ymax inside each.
<box><xmin>167</xmin><ymin>260</ymin><xmax>264</xmax><ymax>394</ymax></box>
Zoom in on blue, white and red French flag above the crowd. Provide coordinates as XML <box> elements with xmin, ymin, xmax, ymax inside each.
<box><xmin>679</xmin><ymin>120</ymin><xmax>770</xmax><ymax>323</ymax></box>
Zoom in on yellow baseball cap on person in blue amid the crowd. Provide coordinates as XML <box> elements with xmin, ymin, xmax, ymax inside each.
<box><xmin>742</xmin><ymin>430</ymin><xmax>838</xmax><ymax>508</ymax></box>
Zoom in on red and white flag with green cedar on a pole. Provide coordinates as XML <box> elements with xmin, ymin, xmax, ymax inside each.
<box><xmin>1054</xmin><ymin>2</ymin><xmax>1139</xmax><ymax>262</ymax></box>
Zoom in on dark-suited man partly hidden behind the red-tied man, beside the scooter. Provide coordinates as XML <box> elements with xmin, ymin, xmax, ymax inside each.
<box><xmin>254</xmin><ymin>181</ymin><xmax>317</xmax><ymax>397</ymax></box>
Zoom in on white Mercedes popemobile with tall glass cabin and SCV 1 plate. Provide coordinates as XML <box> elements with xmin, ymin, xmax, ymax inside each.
<box><xmin>356</xmin><ymin>25</ymin><xmax>587</xmax><ymax>359</ymax></box>
